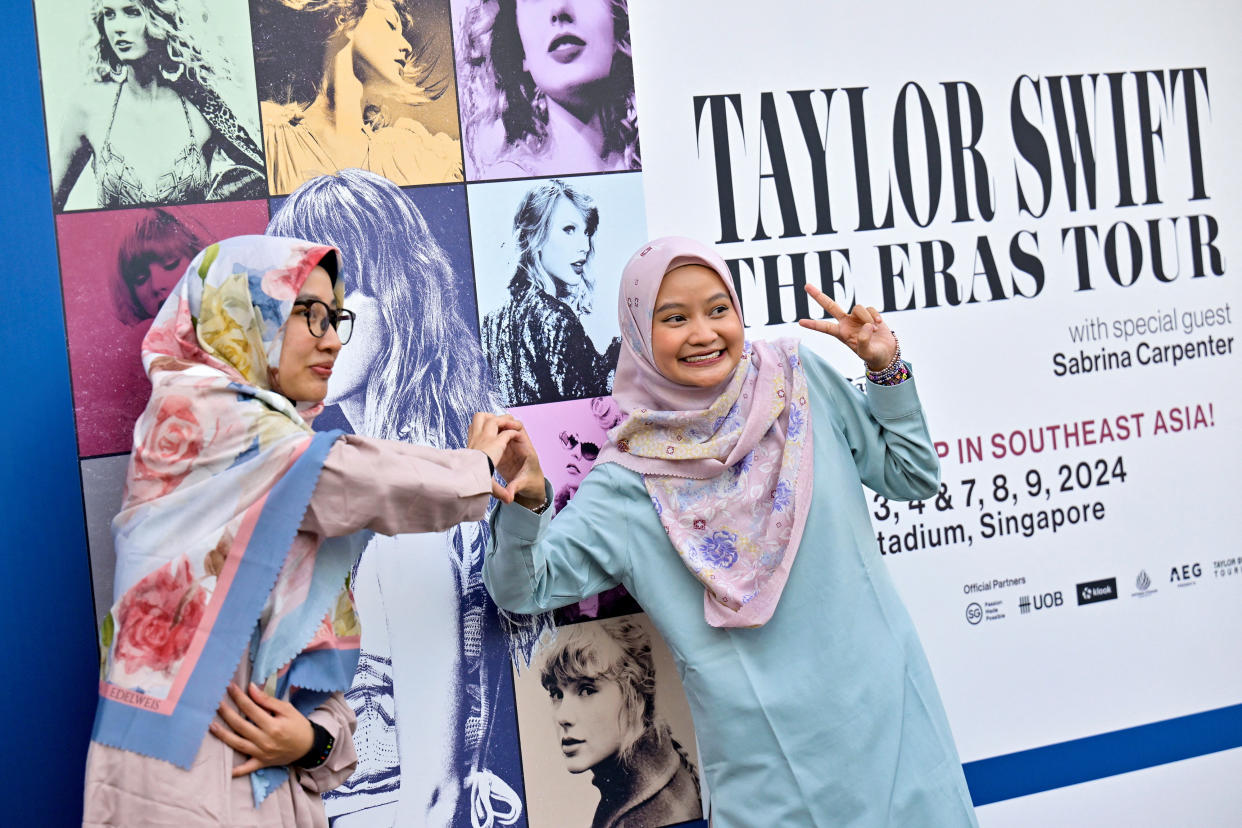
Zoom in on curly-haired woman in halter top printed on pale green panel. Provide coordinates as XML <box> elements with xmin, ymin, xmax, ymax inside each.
<box><xmin>40</xmin><ymin>0</ymin><xmax>265</xmax><ymax>211</ymax></box>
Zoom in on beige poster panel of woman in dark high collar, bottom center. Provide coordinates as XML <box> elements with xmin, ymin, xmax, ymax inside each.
<box><xmin>514</xmin><ymin>613</ymin><xmax>705</xmax><ymax>828</ymax></box>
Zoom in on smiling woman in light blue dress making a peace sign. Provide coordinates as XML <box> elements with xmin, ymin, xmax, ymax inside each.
<box><xmin>484</xmin><ymin>238</ymin><xmax>975</xmax><ymax>828</ymax></box>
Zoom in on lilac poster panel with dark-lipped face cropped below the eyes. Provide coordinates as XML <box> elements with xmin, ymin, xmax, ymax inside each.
<box><xmin>453</xmin><ymin>0</ymin><xmax>641</xmax><ymax>180</ymax></box>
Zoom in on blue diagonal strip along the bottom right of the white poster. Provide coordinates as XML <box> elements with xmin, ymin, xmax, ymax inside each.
<box><xmin>963</xmin><ymin>704</ymin><xmax>1242</xmax><ymax>806</ymax></box>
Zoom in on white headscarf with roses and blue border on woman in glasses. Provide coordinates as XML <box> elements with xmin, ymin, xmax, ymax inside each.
<box><xmin>92</xmin><ymin>236</ymin><xmax>365</xmax><ymax>804</ymax></box>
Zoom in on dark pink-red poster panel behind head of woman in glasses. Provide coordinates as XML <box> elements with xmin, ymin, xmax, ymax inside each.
<box><xmin>56</xmin><ymin>200</ymin><xmax>267</xmax><ymax>457</ymax></box>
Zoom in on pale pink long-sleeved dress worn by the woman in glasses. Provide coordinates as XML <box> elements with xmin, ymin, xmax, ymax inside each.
<box><xmin>82</xmin><ymin>436</ymin><xmax>492</xmax><ymax>828</ymax></box>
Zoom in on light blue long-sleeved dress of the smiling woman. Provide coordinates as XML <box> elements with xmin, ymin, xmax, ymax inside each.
<box><xmin>483</xmin><ymin>349</ymin><xmax>976</xmax><ymax>828</ymax></box>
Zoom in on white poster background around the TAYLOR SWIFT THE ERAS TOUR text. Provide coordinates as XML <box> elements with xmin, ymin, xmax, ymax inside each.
<box><xmin>630</xmin><ymin>0</ymin><xmax>1242</xmax><ymax>779</ymax></box>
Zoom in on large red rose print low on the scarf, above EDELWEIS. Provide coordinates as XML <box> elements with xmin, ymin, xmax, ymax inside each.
<box><xmin>113</xmin><ymin>557</ymin><xmax>207</xmax><ymax>677</ymax></box>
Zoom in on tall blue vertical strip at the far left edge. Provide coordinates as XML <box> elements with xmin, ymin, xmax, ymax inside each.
<box><xmin>0</xmin><ymin>1</ymin><xmax>99</xmax><ymax>826</ymax></box>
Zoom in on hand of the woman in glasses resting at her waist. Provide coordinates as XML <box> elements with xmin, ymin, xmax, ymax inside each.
<box><xmin>210</xmin><ymin>683</ymin><xmax>314</xmax><ymax>777</ymax></box>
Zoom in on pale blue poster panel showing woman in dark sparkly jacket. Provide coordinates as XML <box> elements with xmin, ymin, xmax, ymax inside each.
<box><xmin>469</xmin><ymin>173</ymin><xmax>646</xmax><ymax>406</ymax></box>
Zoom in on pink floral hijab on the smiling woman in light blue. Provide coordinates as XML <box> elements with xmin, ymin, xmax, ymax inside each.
<box><xmin>599</xmin><ymin>237</ymin><xmax>812</xmax><ymax>627</ymax></box>
